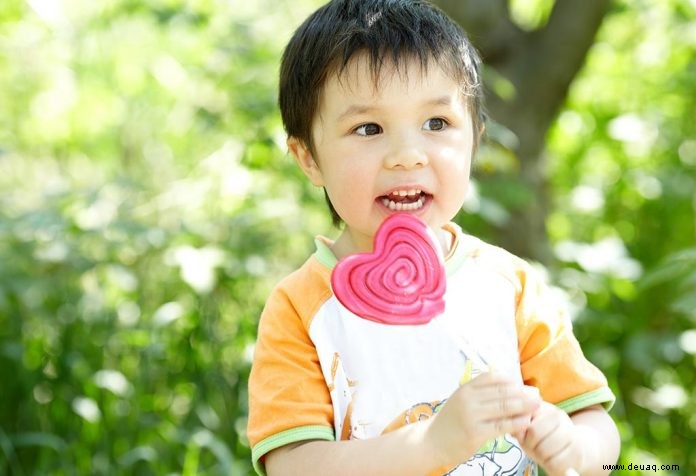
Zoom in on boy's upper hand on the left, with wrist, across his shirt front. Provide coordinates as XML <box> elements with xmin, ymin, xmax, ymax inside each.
<box><xmin>427</xmin><ymin>373</ymin><xmax>541</xmax><ymax>466</ymax></box>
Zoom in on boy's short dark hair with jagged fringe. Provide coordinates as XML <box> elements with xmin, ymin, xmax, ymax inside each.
<box><xmin>278</xmin><ymin>0</ymin><xmax>485</xmax><ymax>225</ymax></box>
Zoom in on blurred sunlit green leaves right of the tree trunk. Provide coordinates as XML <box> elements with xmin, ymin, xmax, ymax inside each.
<box><xmin>547</xmin><ymin>0</ymin><xmax>696</xmax><ymax>472</ymax></box>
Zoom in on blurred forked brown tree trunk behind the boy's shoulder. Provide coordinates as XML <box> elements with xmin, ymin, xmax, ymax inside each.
<box><xmin>434</xmin><ymin>0</ymin><xmax>611</xmax><ymax>264</ymax></box>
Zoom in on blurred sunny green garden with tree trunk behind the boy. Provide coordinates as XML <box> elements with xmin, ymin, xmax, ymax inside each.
<box><xmin>0</xmin><ymin>0</ymin><xmax>696</xmax><ymax>475</ymax></box>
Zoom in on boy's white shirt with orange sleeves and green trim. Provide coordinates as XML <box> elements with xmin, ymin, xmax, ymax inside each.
<box><xmin>247</xmin><ymin>223</ymin><xmax>614</xmax><ymax>476</ymax></box>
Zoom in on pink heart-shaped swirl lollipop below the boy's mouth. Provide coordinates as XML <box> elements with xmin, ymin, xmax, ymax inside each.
<box><xmin>331</xmin><ymin>213</ymin><xmax>445</xmax><ymax>325</ymax></box>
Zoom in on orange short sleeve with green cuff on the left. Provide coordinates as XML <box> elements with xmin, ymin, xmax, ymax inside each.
<box><xmin>247</xmin><ymin>262</ymin><xmax>333</xmax><ymax>470</ymax></box>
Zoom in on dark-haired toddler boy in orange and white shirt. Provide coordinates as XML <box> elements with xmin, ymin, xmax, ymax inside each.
<box><xmin>248</xmin><ymin>0</ymin><xmax>619</xmax><ymax>476</ymax></box>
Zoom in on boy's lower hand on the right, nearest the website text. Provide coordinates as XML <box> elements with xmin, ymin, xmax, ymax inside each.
<box><xmin>513</xmin><ymin>402</ymin><xmax>583</xmax><ymax>476</ymax></box>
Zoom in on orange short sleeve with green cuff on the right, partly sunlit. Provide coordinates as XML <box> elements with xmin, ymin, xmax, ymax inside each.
<box><xmin>516</xmin><ymin>265</ymin><xmax>614</xmax><ymax>413</ymax></box>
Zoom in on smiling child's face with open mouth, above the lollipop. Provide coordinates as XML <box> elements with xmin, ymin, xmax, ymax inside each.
<box><xmin>288</xmin><ymin>53</ymin><xmax>473</xmax><ymax>252</ymax></box>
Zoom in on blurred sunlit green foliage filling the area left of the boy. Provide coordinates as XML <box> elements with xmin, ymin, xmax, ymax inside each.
<box><xmin>0</xmin><ymin>0</ymin><xmax>328</xmax><ymax>474</ymax></box>
